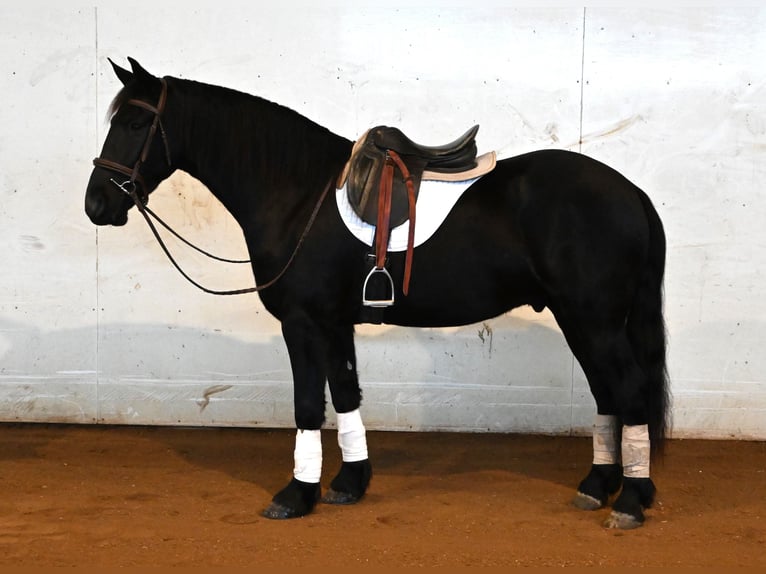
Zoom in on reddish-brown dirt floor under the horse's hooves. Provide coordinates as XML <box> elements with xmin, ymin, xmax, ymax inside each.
<box><xmin>0</xmin><ymin>424</ymin><xmax>766</xmax><ymax>567</ymax></box>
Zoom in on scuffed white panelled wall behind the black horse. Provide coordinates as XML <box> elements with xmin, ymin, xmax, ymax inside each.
<box><xmin>0</xmin><ymin>1</ymin><xmax>766</xmax><ymax>439</ymax></box>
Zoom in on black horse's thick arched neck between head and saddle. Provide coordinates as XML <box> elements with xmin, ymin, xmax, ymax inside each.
<box><xmin>168</xmin><ymin>81</ymin><xmax>351</xmax><ymax>225</ymax></box>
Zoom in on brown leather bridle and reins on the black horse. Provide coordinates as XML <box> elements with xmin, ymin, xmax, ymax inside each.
<box><xmin>93</xmin><ymin>78</ymin><xmax>335</xmax><ymax>295</ymax></box>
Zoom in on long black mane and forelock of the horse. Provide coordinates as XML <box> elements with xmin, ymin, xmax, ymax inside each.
<box><xmin>108</xmin><ymin>78</ymin><xmax>351</xmax><ymax>195</ymax></box>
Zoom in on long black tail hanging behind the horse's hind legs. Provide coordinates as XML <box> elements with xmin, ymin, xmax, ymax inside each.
<box><xmin>627</xmin><ymin>192</ymin><xmax>671</xmax><ymax>462</ymax></box>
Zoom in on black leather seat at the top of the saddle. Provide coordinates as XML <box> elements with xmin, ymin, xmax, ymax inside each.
<box><xmin>370</xmin><ymin>125</ymin><xmax>479</xmax><ymax>173</ymax></box>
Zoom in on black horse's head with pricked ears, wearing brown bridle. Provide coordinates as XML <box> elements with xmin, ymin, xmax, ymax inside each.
<box><xmin>85</xmin><ymin>58</ymin><xmax>174</xmax><ymax>225</ymax></box>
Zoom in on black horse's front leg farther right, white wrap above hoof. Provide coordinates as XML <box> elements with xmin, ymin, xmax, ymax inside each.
<box><xmin>322</xmin><ymin>325</ymin><xmax>372</xmax><ymax>504</ymax></box>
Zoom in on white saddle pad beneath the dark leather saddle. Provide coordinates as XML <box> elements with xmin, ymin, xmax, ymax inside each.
<box><xmin>335</xmin><ymin>177</ymin><xmax>481</xmax><ymax>251</ymax></box>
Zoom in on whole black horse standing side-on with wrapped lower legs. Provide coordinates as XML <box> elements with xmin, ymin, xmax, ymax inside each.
<box><xmin>85</xmin><ymin>59</ymin><xmax>669</xmax><ymax>528</ymax></box>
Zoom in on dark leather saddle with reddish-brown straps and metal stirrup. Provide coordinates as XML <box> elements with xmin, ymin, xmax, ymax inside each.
<box><xmin>338</xmin><ymin>125</ymin><xmax>479</xmax><ymax>307</ymax></box>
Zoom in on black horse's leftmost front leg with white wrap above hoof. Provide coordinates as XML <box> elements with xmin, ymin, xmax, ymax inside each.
<box><xmin>262</xmin><ymin>315</ymin><xmax>327</xmax><ymax>519</ymax></box>
